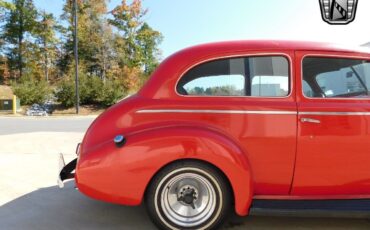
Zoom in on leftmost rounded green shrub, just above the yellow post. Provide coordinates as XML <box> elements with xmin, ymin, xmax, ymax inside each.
<box><xmin>11</xmin><ymin>79</ymin><xmax>51</xmax><ymax>105</ymax></box>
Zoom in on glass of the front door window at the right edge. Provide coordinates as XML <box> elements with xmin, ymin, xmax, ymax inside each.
<box><xmin>303</xmin><ymin>57</ymin><xmax>370</xmax><ymax>98</ymax></box>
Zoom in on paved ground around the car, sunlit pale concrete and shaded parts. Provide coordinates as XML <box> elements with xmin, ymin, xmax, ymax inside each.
<box><xmin>0</xmin><ymin>118</ymin><xmax>370</xmax><ymax>230</ymax></box>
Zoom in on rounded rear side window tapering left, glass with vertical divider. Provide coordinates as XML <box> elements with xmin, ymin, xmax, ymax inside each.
<box><xmin>176</xmin><ymin>56</ymin><xmax>290</xmax><ymax>97</ymax></box>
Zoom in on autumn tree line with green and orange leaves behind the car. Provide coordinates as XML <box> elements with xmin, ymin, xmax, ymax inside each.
<box><xmin>0</xmin><ymin>0</ymin><xmax>163</xmax><ymax>106</ymax></box>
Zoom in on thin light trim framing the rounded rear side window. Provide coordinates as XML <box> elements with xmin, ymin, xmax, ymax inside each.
<box><xmin>174</xmin><ymin>51</ymin><xmax>295</xmax><ymax>99</ymax></box>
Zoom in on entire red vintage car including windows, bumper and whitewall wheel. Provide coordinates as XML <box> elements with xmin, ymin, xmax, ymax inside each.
<box><xmin>59</xmin><ymin>41</ymin><xmax>370</xmax><ymax>229</ymax></box>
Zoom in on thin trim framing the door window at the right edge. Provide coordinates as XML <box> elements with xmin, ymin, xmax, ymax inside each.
<box><xmin>298</xmin><ymin>53</ymin><xmax>370</xmax><ymax>101</ymax></box>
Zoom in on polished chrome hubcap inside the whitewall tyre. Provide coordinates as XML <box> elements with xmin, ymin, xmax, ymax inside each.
<box><xmin>160</xmin><ymin>173</ymin><xmax>216</xmax><ymax>227</ymax></box>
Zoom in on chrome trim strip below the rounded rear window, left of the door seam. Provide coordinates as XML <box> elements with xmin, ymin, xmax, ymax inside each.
<box><xmin>136</xmin><ymin>109</ymin><xmax>297</xmax><ymax>115</ymax></box>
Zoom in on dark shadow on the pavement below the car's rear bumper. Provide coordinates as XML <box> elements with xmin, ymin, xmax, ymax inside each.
<box><xmin>0</xmin><ymin>182</ymin><xmax>155</xmax><ymax>230</ymax></box>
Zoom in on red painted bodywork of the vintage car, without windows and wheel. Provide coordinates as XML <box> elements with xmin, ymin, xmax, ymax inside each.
<box><xmin>60</xmin><ymin>41</ymin><xmax>370</xmax><ymax>218</ymax></box>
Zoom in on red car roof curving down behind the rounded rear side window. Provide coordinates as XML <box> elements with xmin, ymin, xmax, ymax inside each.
<box><xmin>139</xmin><ymin>40</ymin><xmax>370</xmax><ymax>98</ymax></box>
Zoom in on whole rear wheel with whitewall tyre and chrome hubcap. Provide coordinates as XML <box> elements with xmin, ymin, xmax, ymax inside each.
<box><xmin>146</xmin><ymin>161</ymin><xmax>231</xmax><ymax>229</ymax></box>
